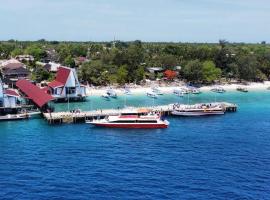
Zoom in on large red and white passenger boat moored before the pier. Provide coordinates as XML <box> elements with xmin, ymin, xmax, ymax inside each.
<box><xmin>86</xmin><ymin>112</ymin><xmax>169</xmax><ymax>129</ymax></box>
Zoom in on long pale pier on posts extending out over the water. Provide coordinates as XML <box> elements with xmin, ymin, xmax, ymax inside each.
<box><xmin>43</xmin><ymin>102</ymin><xmax>237</xmax><ymax>124</ymax></box>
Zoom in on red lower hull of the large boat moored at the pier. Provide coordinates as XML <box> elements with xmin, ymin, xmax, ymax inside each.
<box><xmin>89</xmin><ymin>122</ymin><xmax>168</xmax><ymax>129</ymax></box>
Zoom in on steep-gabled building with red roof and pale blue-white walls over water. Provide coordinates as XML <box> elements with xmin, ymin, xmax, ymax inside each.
<box><xmin>48</xmin><ymin>66</ymin><xmax>86</xmax><ymax>101</ymax></box>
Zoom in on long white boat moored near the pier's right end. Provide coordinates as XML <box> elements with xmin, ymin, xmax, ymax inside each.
<box><xmin>172</xmin><ymin>104</ymin><xmax>225</xmax><ymax>117</ymax></box>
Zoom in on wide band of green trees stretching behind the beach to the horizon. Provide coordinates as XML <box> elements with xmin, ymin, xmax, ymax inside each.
<box><xmin>0</xmin><ymin>39</ymin><xmax>270</xmax><ymax>85</ymax></box>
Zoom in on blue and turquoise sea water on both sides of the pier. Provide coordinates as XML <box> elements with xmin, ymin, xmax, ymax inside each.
<box><xmin>0</xmin><ymin>91</ymin><xmax>270</xmax><ymax>200</ymax></box>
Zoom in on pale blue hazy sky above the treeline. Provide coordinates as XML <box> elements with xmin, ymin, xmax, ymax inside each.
<box><xmin>0</xmin><ymin>0</ymin><xmax>270</xmax><ymax>43</ymax></box>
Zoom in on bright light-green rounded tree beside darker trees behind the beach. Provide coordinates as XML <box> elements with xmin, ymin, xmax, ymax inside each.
<box><xmin>202</xmin><ymin>61</ymin><xmax>221</xmax><ymax>83</ymax></box>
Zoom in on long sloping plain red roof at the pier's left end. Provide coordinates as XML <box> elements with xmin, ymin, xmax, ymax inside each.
<box><xmin>16</xmin><ymin>79</ymin><xmax>54</xmax><ymax>108</ymax></box>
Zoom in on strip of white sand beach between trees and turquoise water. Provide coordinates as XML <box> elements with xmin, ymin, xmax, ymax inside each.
<box><xmin>86</xmin><ymin>81</ymin><xmax>270</xmax><ymax>96</ymax></box>
